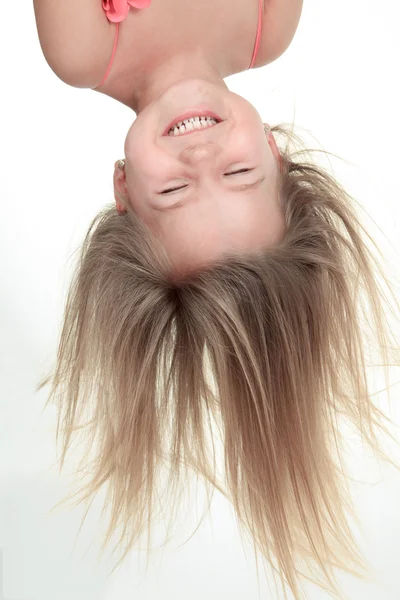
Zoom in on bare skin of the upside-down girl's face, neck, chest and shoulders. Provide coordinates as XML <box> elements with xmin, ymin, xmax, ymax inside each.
<box><xmin>34</xmin><ymin>0</ymin><xmax>303</xmax><ymax>271</ymax></box>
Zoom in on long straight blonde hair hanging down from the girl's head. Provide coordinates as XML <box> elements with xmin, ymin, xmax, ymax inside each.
<box><xmin>39</xmin><ymin>127</ymin><xmax>400</xmax><ymax>600</ymax></box>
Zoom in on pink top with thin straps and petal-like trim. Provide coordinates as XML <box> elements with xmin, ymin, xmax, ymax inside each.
<box><xmin>97</xmin><ymin>0</ymin><xmax>263</xmax><ymax>87</ymax></box>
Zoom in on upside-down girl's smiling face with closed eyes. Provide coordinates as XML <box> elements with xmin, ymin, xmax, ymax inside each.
<box><xmin>120</xmin><ymin>79</ymin><xmax>284</xmax><ymax>268</ymax></box>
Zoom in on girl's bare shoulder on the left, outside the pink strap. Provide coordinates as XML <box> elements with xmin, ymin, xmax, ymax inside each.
<box><xmin>33</xmin><ymin>0</ymin><xmax>115</xmax><ymax>87</ymax></box>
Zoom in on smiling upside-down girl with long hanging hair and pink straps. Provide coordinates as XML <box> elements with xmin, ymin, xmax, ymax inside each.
<box><xmin>34</xmin><ymin>0</ymin><xmax>398</xmax><ymax>600</ymax></box>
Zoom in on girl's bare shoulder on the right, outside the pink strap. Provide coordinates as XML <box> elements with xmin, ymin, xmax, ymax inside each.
<box><xmin>256</xmin><ymin>0</ymin><xmax>303</xmax><ymax>67</ymax></box>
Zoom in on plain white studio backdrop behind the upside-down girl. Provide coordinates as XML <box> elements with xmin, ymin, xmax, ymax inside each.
<box><xmin>0</xmin><ymin>0</ymin><xmax>400</xmax><ymax>600</ymax></box>
